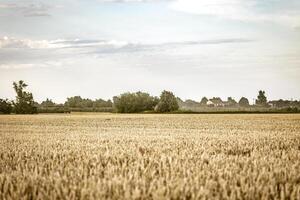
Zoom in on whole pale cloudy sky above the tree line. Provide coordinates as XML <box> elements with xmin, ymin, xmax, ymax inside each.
<box><xmin>0</xmin><ymin>0</ymin><xmax>300</xmax><ymax>103</ymax></box>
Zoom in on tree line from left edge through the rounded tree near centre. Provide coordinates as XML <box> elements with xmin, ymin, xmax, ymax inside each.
<box><xmin>0</xmin><ymin>80</ymin><xmax>179</xmax><ymax>114</ymax></box>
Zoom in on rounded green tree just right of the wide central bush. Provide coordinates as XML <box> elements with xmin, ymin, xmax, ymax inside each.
<box><xmin>155</xmin><ymin>91</ymin><xmax>179</xmax><ymax>113</ymax></box>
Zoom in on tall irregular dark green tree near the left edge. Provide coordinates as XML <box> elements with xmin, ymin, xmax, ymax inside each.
<box><xmin>13</xmin><ymin>80</ymin><xmax>37</xmax><ymax>114</ymax></box>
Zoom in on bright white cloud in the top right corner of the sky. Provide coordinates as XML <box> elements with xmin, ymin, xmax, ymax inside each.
<box><xmin>170</xmin><ymin>0</ymin><xmax>300</xmax><ymax>25</ymax></box>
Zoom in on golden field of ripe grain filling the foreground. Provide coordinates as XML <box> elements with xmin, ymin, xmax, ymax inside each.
<box><xmin>0</xmin><ymin>114</ymin><xmax>300</xmax><ymax>199</ymax></box>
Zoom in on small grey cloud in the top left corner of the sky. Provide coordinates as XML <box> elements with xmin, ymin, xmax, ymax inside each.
<box><xmin>0</xmin><ymin>2</ymin><xmax>52</xmax><ymax>17</ymax></box>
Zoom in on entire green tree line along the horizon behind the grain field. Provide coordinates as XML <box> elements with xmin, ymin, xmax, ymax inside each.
<box><xmin>0</xmin><ymin>80</ymin><xmax>300</xmax><ymax>114</ymax></box>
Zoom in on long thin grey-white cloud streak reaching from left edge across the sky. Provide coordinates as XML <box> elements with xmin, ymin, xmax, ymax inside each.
<box><xmin>0</xmin><ymin>36</ymin><xmax>254</xmax><ymax>52</ymax></box>
